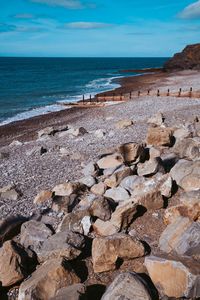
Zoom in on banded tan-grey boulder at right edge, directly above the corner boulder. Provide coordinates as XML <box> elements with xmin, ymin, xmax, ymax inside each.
<box><xmin>159</xmin><ymin>217</ymin><xmax>200</xmax><ymax>257</ymax></box>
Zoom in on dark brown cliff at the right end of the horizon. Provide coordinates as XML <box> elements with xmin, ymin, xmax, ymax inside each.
<box><xmin>164</xmin><ymin>43</ymin><xmax>200</xmax><ymax>71</ymax></box>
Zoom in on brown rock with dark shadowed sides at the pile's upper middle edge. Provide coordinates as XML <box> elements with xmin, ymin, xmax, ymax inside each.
<box><xmin>119</xmin><ymin>143</ymin><xmax>145</xmax><ymax>163</ymax></box>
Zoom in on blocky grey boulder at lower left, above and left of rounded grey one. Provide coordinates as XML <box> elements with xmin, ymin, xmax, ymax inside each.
<box><xmin>20</xmin><ymin>220</ymin><xmax>53</xmax><ymax>251</ymax></box>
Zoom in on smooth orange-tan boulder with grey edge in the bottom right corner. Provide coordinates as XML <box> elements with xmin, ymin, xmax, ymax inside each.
<box><xmin>145</xmin><ymin>256</ymin><xmax>200</xmax><ymax>299</ymax></box>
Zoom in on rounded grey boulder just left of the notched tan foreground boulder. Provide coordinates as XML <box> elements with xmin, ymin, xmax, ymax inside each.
<box><xmin>37</xmin><ymin>231</ymin><xmax>85</xmax><ymax>262</ymax></box>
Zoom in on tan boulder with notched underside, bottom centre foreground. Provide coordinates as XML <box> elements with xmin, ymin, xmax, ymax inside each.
<box><xmin>92</xmin><ymin>233</ymin><xmax>145</xmax><ymax>273</ymax></box>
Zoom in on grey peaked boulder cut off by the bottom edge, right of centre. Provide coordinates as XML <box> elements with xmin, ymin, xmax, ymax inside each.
<box><xmin>101</xmin><ymin>272</ymin><xmax>152</xmax><ymax>300</ymax></box>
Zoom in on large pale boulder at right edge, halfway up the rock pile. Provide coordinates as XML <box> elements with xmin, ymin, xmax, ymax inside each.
<box><xmin>170</xmin><ymin>159</ymin><xmax>200</xmax><ymax>192</ymax></box>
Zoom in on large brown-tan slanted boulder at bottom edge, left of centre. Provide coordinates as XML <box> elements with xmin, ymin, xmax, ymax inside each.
<box><xmin>18</xmin><ymin>258</ymin><xmax>80</xmax><ymax>300</ymax></box>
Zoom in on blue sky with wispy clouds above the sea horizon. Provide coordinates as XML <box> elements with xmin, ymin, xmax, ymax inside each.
<box><xmin>0</xmin><ymin>0</ymin><xmax>200</xmax><ymax>57</ymax></box>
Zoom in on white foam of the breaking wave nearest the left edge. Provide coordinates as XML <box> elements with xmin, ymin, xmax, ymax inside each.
<box><xmin>0</xmin><ymin>104</ymin><xmax>67</xmax><ymax>126</ymax></box>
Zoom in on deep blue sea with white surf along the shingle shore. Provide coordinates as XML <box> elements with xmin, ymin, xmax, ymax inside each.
<box><xmin>0</xmin><ymin>57</ymin><xmax>168</xmax><ymax>125</ymax></box>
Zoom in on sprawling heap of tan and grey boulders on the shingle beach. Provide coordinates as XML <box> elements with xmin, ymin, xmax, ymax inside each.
<box><xmin>0</xmin><ymin>114</ymin><xmax>200</xmax><ymax>300</ymax></box>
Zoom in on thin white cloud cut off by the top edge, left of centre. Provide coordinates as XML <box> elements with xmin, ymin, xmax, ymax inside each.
<box><xmin>31</xmin><ymin>0</ymin><xmax>84</xmax><ymax>9</ymax></box>
